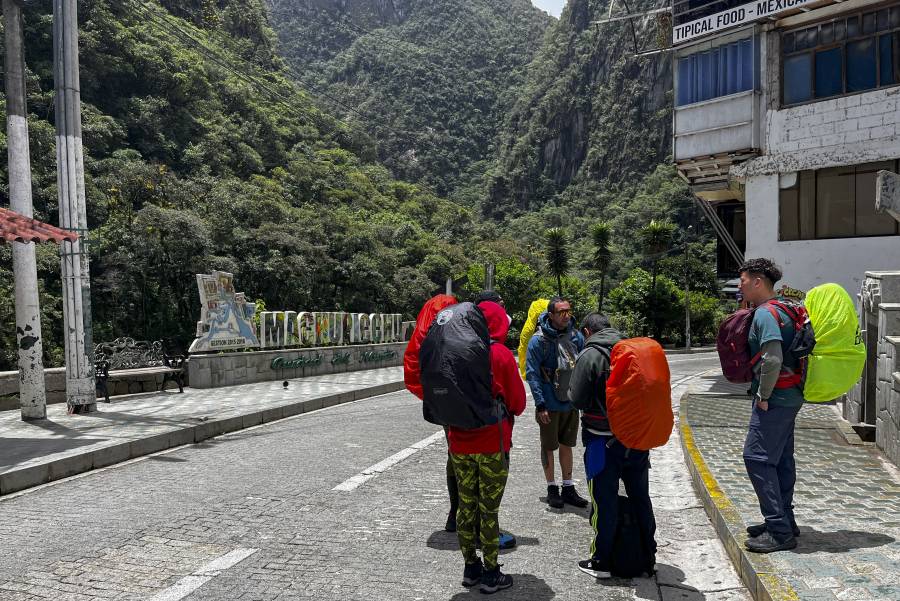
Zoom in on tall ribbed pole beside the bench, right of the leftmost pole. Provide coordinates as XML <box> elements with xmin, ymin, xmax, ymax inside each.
<box><xmin>53</xmin><ymin>0</ymin><xmax>97</xmax><ymax>413</ymax></box>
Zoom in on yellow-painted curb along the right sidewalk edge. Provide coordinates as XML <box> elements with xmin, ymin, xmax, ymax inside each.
<box><xmin>678</xmin><ymin>391</ymin><xmax>800</xmax><ymax>601</ymax></box>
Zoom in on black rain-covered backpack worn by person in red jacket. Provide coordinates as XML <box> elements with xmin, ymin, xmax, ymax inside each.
<box><xmin>419</xmin><ymin>303</ymin><xmax>497</xmax><ymax>430</ymax></box>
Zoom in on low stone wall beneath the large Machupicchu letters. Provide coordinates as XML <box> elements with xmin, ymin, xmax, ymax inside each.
<box><xmin>188</xmin><ymin>342</ymin><xmax>407</xmax><ymax>388</ymax></box>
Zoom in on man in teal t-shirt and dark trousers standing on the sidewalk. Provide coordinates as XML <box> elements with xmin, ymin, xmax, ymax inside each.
<box><xmin>740</xmin><ymin>258</ymin><xmax>803</xmax><ymax>553</ymax></box>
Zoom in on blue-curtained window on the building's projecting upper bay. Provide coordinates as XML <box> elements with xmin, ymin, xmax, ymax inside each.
<box><xmin>677</xmin><ymin>38</ymin><xmax>754</xmax><ymax>106</ymax></box>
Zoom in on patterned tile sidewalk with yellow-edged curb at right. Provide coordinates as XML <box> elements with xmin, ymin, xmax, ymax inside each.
<box><xmin>680</xmin><ymin>381</ymin><xmax>900</xmax><ymax>601</ymax></box>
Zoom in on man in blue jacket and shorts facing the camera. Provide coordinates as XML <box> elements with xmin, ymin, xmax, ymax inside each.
<box><xmin>525</xmin><ymin>296</ymin><xmax>588</xmax><ymax>509</ymax></box>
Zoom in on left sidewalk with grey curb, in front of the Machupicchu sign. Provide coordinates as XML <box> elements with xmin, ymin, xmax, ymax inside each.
<box><xmin>0</xmin><ymin>367</ymin><xmax>403</xmax><ymax>495</ymax></box>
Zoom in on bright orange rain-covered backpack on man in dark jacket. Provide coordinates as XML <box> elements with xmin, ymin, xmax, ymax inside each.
<box><xmin>606</xmin><ymin>338</ymin><xmax>675</xmax><ymax>451</ymax></box>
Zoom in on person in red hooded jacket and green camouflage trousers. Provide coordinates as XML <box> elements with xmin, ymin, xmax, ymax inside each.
<box><xmin>448</xmin><ymin>301</ymin><xmax>525</xmax><ymax>594</ymax></box>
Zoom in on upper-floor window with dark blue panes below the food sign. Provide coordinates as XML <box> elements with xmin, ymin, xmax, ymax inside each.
<box><xmin>781</xmin><ymin>6</ymin><xmax>900</xmax><ymax>105</ymax></box>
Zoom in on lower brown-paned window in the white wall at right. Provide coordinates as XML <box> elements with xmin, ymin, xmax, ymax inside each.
<box><xmin>778</xmin><ymin>161</ymin><xmax>900</xmax><ymax>240</ymax></box>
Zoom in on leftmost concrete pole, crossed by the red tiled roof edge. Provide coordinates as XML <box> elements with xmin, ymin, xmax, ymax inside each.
<box><xmin>3</xmin><ymin>0</ymin><xmax>47</xmax><ymax>419</ymax></box>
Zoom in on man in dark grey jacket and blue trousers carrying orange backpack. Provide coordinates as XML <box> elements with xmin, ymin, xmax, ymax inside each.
<box><xmin>569</xmin><ymin>313</ymin><xmax>656</xmax><ymax>578</ymax></box>
